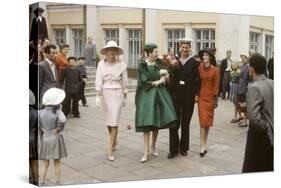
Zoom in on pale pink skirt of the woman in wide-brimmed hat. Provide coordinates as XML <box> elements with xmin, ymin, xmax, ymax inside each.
<box><xmin>102</xmin><ymin>89</ymin><xmax>124</xmax><ymax>127</ymax></box>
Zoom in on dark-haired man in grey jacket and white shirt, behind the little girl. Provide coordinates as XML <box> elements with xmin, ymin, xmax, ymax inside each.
<box><xmin>38</xmin><ymin>44</ymin><xmax>60</xmax><ymax>104</ymax></box>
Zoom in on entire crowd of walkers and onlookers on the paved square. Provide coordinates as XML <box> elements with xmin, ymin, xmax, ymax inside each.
<box><xmin>29</xmin><ymin>9</ymin><xmax>274</xmax><ymax>184</ymax></box>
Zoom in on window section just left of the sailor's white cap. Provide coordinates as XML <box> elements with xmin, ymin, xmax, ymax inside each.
<box><xmin>166</xmin><ymin>29</ymin><xmax>185</xmax><ymax>54</ymax></box>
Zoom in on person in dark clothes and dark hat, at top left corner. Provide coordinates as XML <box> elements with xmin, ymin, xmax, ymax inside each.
<box><xmin>29</xmin><ymin>7</ymin><xmax>48</xmax><ymax>42</ymax></box>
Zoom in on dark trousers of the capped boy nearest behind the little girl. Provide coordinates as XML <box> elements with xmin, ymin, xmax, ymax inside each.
<box><xmin>62</xmin><ymin>92</ymin><xmax>80</xmax><ymax>116</ymax></box>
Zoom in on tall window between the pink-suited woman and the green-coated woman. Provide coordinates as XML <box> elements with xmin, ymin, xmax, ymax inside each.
<box><xmin>128</xmin><ymin>29</ymin><xmax>142</xmax><ymax>69</ymax></box>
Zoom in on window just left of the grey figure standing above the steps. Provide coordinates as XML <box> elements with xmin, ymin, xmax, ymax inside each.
<box><xmin>72</xmin><ymin>29</ymin><xmax>84</xmax><ymax>57</ymax></box>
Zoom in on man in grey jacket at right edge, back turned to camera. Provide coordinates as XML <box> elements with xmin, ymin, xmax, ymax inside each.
<box><xmin>242</xmin><ymin>54</ymin><xmax>274</xmax><ymax>172</ymax></box>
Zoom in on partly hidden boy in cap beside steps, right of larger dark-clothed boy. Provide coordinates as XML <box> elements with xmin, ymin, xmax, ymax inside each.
<box><xmin>77</xmin><ymin>57</ymin><xmax>89</xmax><ymax>107</ymax></box>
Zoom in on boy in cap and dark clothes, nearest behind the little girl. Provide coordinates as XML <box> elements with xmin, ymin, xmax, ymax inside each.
<box><xmin>60</xmin><ymin>57</ymin><xmax>83</xmax><ymax>118</ymax></box>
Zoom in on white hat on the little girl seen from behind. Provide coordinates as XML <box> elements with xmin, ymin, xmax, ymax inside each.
<box><xmin>43</xmin><ymin>87</ymin><xmax>65</xmax><ymax>105</ymax></box>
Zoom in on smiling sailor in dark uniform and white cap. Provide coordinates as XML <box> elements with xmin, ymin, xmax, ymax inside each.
<box><xmin>168</xmin><ymin>39</ymin><xmax>200</xmax><ymax>159</ymax></box>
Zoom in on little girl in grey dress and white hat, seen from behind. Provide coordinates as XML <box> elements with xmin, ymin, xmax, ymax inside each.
<box><xmin>39</xmin><ymin>88</ymin><xmax>67</xmax><ymax>185</ymax></box>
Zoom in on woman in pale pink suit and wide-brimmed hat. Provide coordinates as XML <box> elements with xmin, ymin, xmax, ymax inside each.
<box><xmin>96</xmin><ymin>41</ymin><xmax>128</xmax><ymax>161</ymax></box>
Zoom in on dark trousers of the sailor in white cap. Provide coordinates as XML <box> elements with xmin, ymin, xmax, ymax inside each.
<box><xmin>169</xmin><ymin>87</ymin><xmax>195</xmax><ymax>153</ymax></box>
